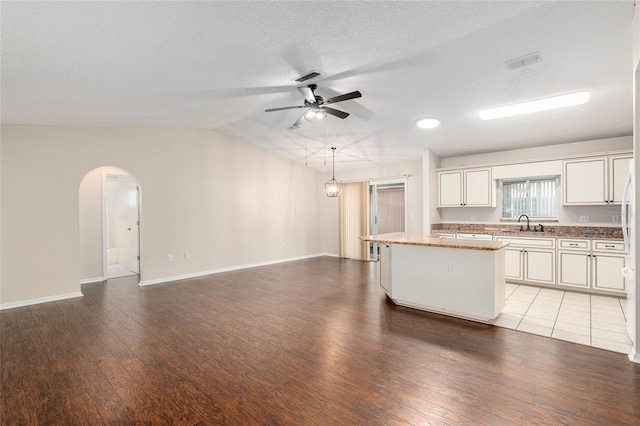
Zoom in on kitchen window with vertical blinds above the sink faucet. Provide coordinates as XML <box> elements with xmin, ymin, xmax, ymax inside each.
<box><xmin>502</xmin><ymin>178</ymin><xmax>558</xmax><ymax>218</ymax></box>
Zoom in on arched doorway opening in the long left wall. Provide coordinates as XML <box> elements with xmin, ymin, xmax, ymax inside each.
<box><xmin>79</xmin><ymin>167</ymin><xmax>140</xmax><ymax>284</ymax></box>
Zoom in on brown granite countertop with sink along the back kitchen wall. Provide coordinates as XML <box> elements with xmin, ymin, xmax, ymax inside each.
<box><xmin>431</xmin><ymin>223</ymin><xmax>623</xmax><ymax>240</ymax></box>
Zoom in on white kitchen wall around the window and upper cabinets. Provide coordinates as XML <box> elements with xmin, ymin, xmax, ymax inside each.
<box><xmin>432</xmin><ymin>136</ymin><xmax>633</xmax><ymax>226</ymax></box>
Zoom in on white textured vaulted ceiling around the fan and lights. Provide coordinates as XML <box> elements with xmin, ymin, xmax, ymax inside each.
<box><xmin>1</xmin><ymin>1</ymin><xmax>634</xmax><ymax>171</ymax></box>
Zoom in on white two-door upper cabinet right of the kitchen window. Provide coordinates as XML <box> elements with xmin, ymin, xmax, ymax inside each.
<box><xmin>563</xmin><ymin>153</ymin><xmax>633</xmax><ymax>206</ymax></box>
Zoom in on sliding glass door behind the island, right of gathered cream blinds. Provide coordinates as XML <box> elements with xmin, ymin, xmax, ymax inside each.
<box><xmin>369</xmin><ymin>178</ymin><xmax>407</xmax><ymax>261</ymax></box>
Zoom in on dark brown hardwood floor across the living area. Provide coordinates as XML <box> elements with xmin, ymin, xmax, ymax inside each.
<box><xmin>0</xmin><ymin>257</ymin><xmax>640</xmax><ymax>425</ymax></box>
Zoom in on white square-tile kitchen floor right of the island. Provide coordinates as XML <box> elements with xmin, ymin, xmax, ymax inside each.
<box><xmin>491</xmin><ymin>283</ymin><xmax>631</xmax><ymax>354</ymax></box>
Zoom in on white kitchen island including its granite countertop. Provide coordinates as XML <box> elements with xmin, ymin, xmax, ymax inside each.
<box><xmin>361</xmin><ymin>232</ymin><xmax>508</xmax><ymax>322</ymax></box>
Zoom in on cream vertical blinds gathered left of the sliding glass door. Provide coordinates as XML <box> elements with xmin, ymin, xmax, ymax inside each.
<box><xmin>338</xmin><ymin>182</ymin><xmax>370</xmax><ymax>260</ymax></box>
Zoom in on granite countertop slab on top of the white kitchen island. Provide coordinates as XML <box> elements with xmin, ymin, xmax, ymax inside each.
<box><xmin>360</xmin><ymin>232</ymin><xmax>509</xmax><ymax>250</ymax></box>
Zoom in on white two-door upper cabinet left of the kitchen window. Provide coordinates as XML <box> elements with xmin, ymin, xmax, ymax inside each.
<box><xmin>436</xmin><ymin>168</ymin><xmax>493</xmax><ymax>207</ymax></box>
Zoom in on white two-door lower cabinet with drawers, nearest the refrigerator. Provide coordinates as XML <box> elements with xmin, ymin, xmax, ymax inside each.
<box><xmin>558</xmin><ymin>238</ymin><xmax>627</xmax><ymax>293</ymax></box>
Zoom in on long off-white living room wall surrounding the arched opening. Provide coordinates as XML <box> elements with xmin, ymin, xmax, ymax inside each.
<box><xmin>0</xmin><ymin>125</ymin><xmax>325</xmax><ymax>307</ymax></box>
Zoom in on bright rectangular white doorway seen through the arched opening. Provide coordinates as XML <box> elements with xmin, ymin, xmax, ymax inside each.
<box><xmin>104</xmin><ymin>174</ymin><xmax>140</xmax><ymax>278</ymax></box>
